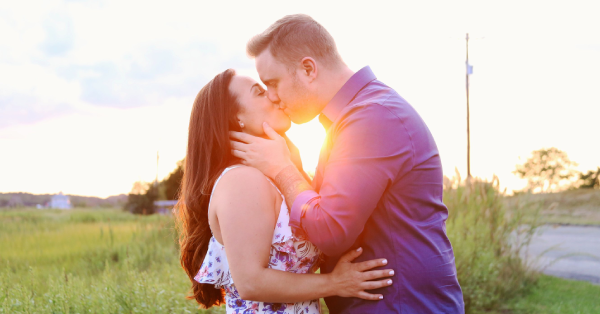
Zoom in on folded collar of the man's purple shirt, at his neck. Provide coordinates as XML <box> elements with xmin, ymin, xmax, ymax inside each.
<box><xmin>321</xmin><ymin>66</ymin><xmax>377</xmax><ymax>122</ymax></box>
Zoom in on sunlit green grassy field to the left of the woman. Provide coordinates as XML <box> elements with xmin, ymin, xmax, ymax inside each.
<box><xmin>0</xmin><ymin>210</ymin><xmax>223</xmax><ymax>313</ymax></box>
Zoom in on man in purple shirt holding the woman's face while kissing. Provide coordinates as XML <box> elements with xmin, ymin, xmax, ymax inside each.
<box><xmin>231</xmin><ymin>15</ymin><xmax>464</xmax><ymax>313</ymax></box>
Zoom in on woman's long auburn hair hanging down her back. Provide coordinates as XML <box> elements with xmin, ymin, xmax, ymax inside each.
<box><xmin>176</xmin><ymin>69</ymin><xmax>241</xmax><ymax>308</ymax></box>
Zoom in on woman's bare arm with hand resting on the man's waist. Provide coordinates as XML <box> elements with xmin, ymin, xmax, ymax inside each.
<box><xmin>211</xmin><ymin>167</ymin><xmax>391</xmax><ymax>303</ymax></box>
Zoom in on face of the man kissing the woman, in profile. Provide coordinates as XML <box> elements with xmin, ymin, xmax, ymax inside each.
<box><xmin>255</xmin><ymin>49</ymin><xmax>319</xmax><ymax>124</ymax></box>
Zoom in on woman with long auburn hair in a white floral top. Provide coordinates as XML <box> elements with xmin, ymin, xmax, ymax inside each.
<box><xmin>178</xmin><ymin>69</ymin><xmax>391</xmax><ymax>314</ymax></box>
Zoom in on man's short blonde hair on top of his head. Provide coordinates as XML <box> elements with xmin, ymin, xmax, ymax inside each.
<box><xmin>246</xmin><ymin>14</ymin><xmax>342</xmax><ymax>67</ymax></box>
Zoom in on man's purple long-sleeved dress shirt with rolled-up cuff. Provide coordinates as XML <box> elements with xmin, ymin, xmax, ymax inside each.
<box><xmin>290</xmin><ymin>67</ymin><xmax>464</xmax><ymax>314</ymax></box>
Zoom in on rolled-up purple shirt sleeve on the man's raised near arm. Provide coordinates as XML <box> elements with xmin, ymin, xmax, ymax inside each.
<box><xmin>290</xmin><ymin>104</ymin><xmax>414</xmax><ymax>256</ymax></box>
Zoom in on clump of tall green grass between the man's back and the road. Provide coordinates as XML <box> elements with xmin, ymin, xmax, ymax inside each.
<box><xmin>444</xmin><ymin>174</ymin><xmax>537</xmax><ymax>313</ymax></box>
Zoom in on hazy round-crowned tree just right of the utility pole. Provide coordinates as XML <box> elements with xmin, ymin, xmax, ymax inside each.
<box><xmin>513</xmin><ymin>147</ymin><xmax>578</xmax><ymax>192</ymax></box>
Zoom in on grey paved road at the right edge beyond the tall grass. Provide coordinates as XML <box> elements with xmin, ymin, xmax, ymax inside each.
<box><xmin>528</xmin><ymin>225</ymin><xmax>600</xmax><ymax>284</ymax></box>
